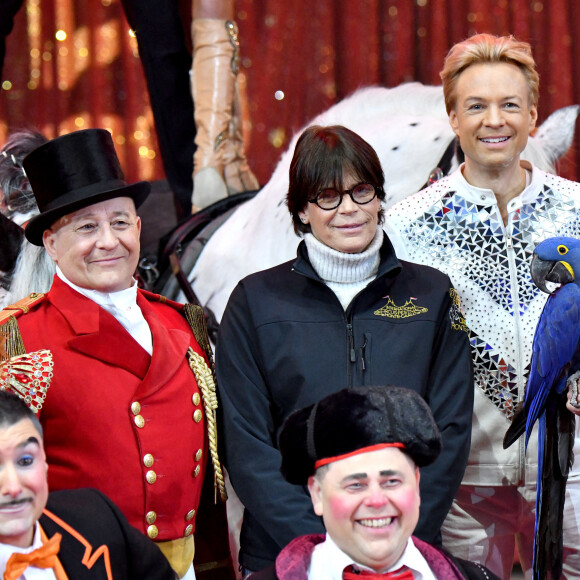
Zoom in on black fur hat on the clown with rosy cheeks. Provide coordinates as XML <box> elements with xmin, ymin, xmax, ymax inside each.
<box><xmin>278</xmin><ymin>386</ymin><xmax>441</xmax><ymax>485</ymax></box>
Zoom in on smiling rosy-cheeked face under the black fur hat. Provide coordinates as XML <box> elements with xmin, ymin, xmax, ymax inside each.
<box><xmin>308</xmin><ymin>447</ymin><xmax>421</xmax><ymax>572</ymax></box>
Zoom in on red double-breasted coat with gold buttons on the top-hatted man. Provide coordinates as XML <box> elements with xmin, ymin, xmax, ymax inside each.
<box><xmin>18</xmin><ymin>277</ymin><xmax>207</xmax><ymax>541</ymax></box>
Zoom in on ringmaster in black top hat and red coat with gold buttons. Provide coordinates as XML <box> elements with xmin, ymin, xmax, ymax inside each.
<box><xmin>0</xmin><ymin>129</ymin><xmax>231</xmax><ymax>578</ymax></box>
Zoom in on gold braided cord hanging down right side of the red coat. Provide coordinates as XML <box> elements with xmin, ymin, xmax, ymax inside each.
<box><xmin>187</xmin><ymin>347</ymin><xmax>228</xmax><ymax>501</ymax></box>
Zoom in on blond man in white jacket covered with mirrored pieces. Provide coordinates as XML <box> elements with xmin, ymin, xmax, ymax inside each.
<box><xmin>386</xmin><ymin>34</ymin><xmax>580</xmax><ymax>578</ymax></box>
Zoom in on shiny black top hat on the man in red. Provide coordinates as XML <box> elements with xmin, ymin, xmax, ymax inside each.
<box><xmin>22</xmin><ymin>129</ymin><xmax>151</xmax><ymax>246</ymax></box>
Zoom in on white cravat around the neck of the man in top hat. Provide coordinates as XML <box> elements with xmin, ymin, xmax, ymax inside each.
<box><xmin>56</xmin><ymin>266</ymin><xmax>153</xmax><ymax>354</ymax></box>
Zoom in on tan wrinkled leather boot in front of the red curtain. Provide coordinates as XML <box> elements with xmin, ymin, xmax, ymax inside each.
<box><xmin>191</xmin><ymin>18</ymin><xmax>258</xmax><ymax>209</ymax></box>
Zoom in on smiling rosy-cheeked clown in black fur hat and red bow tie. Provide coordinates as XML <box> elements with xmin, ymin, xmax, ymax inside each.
<box><xmin>249</xmin><ymin>387</ymin><xmax>497</xmax><ymax>580</ymax></box>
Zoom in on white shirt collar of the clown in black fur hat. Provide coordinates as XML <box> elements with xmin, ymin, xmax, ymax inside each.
<box><xmin>308</xmin><ymin>534</ymin><xmax>437</xmax><ymax>580</ymax></box>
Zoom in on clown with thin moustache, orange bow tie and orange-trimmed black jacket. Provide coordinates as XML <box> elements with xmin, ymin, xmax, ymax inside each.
<box><xmin>0</xmin><ymin>390</ymin><xmax>176</xmax><ymax>580</ymax></box>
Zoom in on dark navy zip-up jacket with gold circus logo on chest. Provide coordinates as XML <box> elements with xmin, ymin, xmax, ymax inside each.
<box><xmin>216</xmin><ymin>236</ymin><xmax>473</xmax><ymax>570</ymax></box>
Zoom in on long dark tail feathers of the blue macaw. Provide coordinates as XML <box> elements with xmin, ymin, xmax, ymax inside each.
<box><xmin>533</xmin><ymin>394</ymin><xmax>574</xmax><ymax>580</ymax></box>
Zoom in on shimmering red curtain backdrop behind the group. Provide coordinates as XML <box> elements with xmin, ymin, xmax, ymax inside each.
<box><xmin>0</xmin><ymin>0</ymin><xmax>580</xmax><ymax>188</ymax></box>
